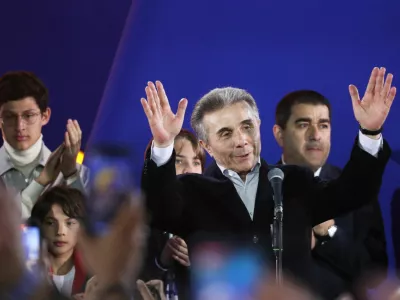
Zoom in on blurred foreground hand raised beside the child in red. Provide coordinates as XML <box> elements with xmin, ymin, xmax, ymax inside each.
<box><xmin>78</xmin><ymin>195</ymin><xmax>146</xmax><ymax>290</ymax></box>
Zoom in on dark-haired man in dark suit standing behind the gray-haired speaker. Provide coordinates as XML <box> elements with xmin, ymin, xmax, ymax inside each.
<box><xmin>273</xmin><ymin>90</ymin><xmax>388</xmax><ymax>299</ymax></box>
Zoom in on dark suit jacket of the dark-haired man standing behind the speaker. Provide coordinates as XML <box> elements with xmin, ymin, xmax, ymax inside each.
<box><xmin>294</xmin><ymin>164</ymin><xmax>388</xmax><ymax>299</ymax></box>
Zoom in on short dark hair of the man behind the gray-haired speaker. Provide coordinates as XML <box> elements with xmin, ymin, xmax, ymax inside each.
<box><xmin>275</xmin><ymin>90</ymin><xmax>332</xmax><ymax>129</ymax></box>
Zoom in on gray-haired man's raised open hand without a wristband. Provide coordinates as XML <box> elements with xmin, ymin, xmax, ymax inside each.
<box><xmin>140</xmin><ymin>81</ymin><xmax>187</xmax><ymax>147</ymax></box>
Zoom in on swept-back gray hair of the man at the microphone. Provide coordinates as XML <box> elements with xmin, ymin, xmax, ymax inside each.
<box><xmin>190</xmin><ymin>87</ymin><xmax>260</xmax><ymax>141</ymax></box>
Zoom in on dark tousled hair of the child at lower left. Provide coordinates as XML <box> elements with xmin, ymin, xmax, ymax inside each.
<box><xmin>31</xmin><ymin>185</ymin><xmax>85</xmax><ymax>224</ymax></box>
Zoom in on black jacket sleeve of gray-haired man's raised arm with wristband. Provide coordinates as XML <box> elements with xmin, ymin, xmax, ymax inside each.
<box><xmin>306</xmin><ymin>137</ymin><xmax>391</xmax><ymax>226</ymax></box>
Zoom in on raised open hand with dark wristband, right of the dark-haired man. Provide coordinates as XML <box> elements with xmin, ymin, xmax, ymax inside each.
<box><xmin>349</xmin><ymin>68</ymin><xmax>396</xmax><ymax>130</ymax></box>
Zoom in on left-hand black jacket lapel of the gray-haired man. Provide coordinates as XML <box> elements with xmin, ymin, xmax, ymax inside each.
<box><xmin>204</xmin><ymin>162</ymin><xmax>251</xmax><ymax>225</ymax></box>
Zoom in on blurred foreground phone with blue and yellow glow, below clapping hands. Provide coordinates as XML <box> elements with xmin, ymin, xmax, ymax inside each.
<box><xmin>85</xmin><ymin>145</ymin><xmax>134</xmax><ymax>236</ymax></box>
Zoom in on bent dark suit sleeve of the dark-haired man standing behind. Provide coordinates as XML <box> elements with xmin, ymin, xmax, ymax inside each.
<box><xmin>313</xmin><ymin>201</ymin><xmax>388</xmax><ymax>288</ymax></box>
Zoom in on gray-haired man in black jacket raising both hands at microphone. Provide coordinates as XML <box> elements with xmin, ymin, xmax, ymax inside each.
<box><xmin>141</xmin><ymin>68</ymin><xmax>396</xmax><ymax>298</ymax></box>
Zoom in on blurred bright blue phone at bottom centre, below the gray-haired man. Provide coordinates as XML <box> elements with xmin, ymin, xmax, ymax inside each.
<box><xmin>191</xmin><ymin>242</ymin><xmax>265</xmax><ymax>300</ymax></box>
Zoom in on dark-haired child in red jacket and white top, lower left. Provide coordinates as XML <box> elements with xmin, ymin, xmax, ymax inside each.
<box><xmin>31</xmin><ymin>186</ymin><xmax>89</xmax><ymax>296</ymax></box>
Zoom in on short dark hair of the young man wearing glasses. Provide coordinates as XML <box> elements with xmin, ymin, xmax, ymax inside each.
<box><xmin>0</xmin><ymin>71</ymin><xmax>49</xmax><ymax>113</ymax></box>
